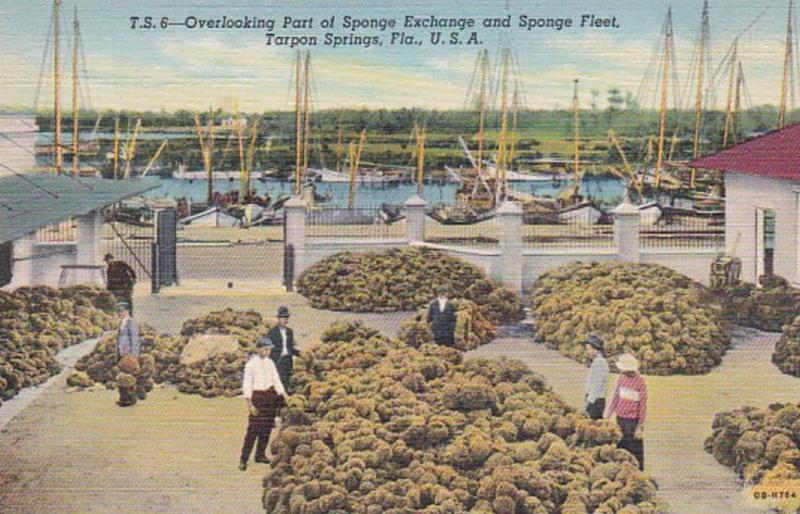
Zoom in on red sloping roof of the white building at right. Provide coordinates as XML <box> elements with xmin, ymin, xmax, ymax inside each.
<box><xmin>689</xmin><ymin>123</ymin><xmax>800</xmax><ymax>180</ymax></box>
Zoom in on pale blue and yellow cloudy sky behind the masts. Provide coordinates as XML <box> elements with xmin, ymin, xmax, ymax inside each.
<box><xmin>0</xmin><ymin>0</ymin><xmax>800</xmax><ymax>112</ymax></box>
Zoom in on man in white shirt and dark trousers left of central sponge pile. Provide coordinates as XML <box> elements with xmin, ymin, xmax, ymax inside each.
<box><xmin>239</xmin><ymin>338</ymin><xmax>286</xmax><ymax>471</ymax></box>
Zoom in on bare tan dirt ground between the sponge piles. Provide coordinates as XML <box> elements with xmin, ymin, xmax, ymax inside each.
<box><xmin>0</xmin><ymin>284</ymin><xmax>800</xmax><ymax>514</ymax></box>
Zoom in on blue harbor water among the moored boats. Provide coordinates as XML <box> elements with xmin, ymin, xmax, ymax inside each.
<box><xmin>146</xmin><ymin>177</ymin><xmax>624</xmax><ymax>207</ymax></box>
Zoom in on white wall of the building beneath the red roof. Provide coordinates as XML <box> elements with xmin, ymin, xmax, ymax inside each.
<box><xmin>725</xmin><ymin>172</ymin><xmax>800</xmax><ymax>283</ymax></box>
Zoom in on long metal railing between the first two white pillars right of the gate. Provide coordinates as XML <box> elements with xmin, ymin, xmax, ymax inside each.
<box><xmin>306</xmin><ymin>207</ymin><xmax>406</xmax><ymax>239</ymax></box>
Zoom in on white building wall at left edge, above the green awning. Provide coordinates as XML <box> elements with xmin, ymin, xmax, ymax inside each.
<box><xmin>0</xmin><ymin>113</ymin><xmax>38</xmax><ymax>177</ymax></box>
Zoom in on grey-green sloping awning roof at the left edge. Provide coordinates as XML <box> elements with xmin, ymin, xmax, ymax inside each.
<box><xmin>0</xmin><ymin>173</ymin><xmax>161</xmax><ymax>243</ymax></box>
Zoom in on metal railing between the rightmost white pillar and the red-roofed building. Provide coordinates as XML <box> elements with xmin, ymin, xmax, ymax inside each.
<box><xmin>639</xmin><ymin>211</ymin><xmax>725</xmax><ymax>249</ymax></box>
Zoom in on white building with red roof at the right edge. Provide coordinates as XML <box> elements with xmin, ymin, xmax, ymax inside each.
<box><xmin>689</xmin><ymin>124</ymin><xmax>800</xmax><ymax>284</ymax></box>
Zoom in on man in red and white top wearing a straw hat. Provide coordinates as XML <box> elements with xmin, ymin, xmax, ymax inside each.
<box><xmin>606</xmin><ymin>353</ymin><xmax>647</xmax><ymax>470</ymax></box>
